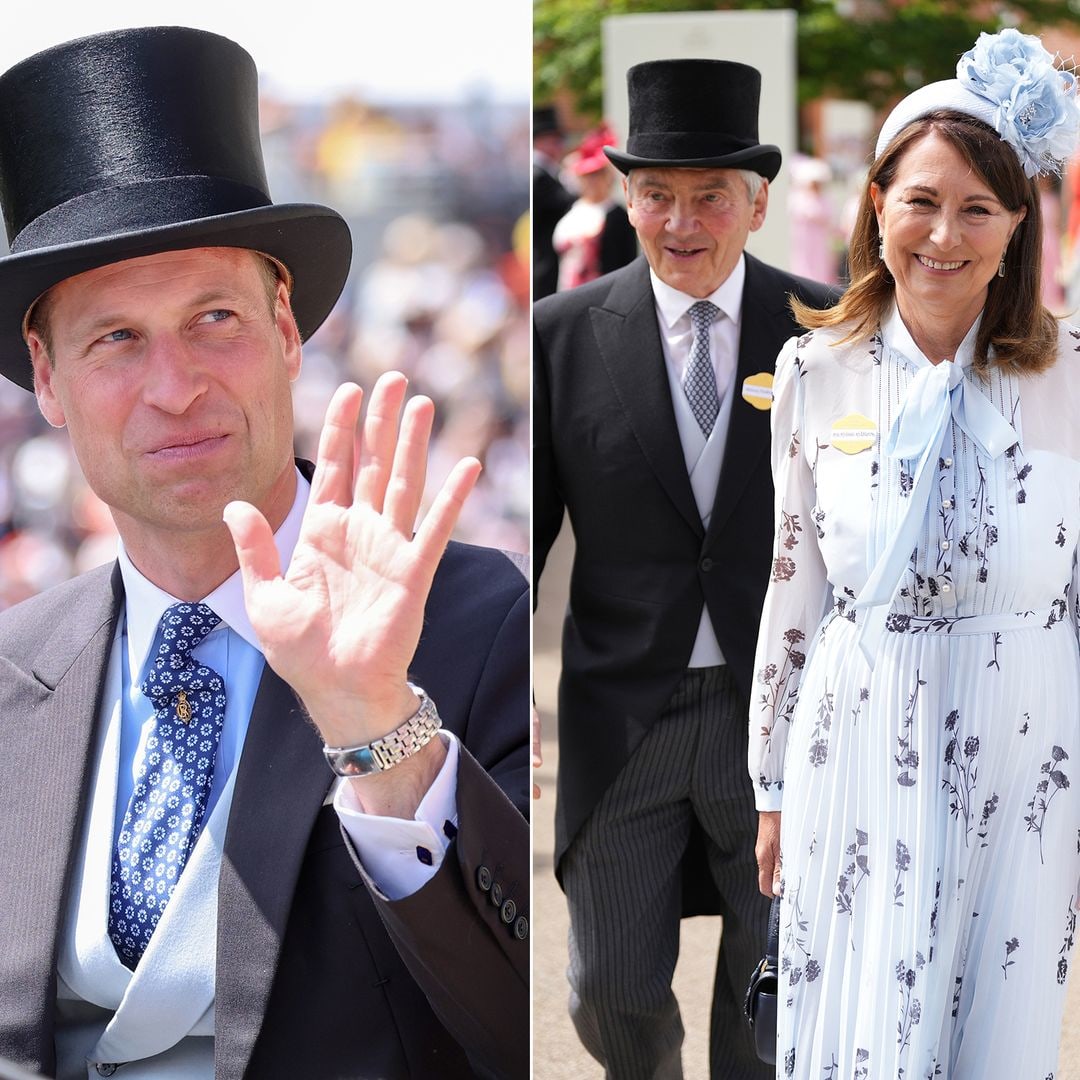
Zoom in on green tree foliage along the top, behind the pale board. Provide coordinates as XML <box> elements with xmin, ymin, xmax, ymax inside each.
<box><xmin>532</xmin><ymin>0</ymin><xmax>1080</xmax><ymax>120</ymax></box>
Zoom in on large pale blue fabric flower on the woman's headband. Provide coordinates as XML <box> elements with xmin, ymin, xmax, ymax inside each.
<box><xmin>956</xmin><ymin>29</ymin><xmax>1080</xmax><ymax>176</ymax></box>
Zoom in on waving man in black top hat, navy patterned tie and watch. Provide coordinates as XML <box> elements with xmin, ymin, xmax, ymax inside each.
<box><xmin>0</xmin><ymin>27</ymin><xmax>529</xmax><ymax>1080</ymax></box>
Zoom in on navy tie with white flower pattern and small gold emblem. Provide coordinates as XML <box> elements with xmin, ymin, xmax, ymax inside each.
<box><xmin>109</xmin><ymin>604</ymin><xmax>225</xmax><ymax>969</ymax></box>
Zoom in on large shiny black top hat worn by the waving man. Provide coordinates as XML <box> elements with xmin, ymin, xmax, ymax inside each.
<box><xmin>0</xmin><ymin>27</ymin><xmax>352</xmax><ymax>389</ymax></box>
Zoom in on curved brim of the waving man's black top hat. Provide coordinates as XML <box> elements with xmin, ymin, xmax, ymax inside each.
<box><xmin>0</xmin><ymin>203</ymin><xmax>352</xmax><ymax>390</ymax></box>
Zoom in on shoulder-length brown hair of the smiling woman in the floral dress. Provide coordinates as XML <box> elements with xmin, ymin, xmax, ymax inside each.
<box><xmin>792</xmin><ymin>109</ymin><xmax>1057</xmax><ymax>372</ymax></box>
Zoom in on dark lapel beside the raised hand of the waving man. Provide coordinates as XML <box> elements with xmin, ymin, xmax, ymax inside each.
<box><xmin>214</xmin><ymin>665</ymin><xmax>334</xmax><ymax>1080</ymax></box>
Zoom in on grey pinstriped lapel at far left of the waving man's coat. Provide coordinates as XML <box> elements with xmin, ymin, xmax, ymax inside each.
<box><xmin>0</xmin><ymin>568</ymin><xmax>123</xmax><ymax>1072</ymax></box>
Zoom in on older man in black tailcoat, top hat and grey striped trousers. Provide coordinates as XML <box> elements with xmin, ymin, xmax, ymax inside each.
<box><xmin>534</xmin><ymin>59</ymin><xmax>826</xmax><ymax>1080</ymax></box>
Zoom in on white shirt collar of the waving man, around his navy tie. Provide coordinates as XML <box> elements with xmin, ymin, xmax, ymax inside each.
<box><xmin>117</xmin><ymin>471</ymin><xmax>311</xmax><ymax>672</ymax></box>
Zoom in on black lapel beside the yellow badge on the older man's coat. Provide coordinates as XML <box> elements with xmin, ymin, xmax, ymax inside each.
<box><xmin>708</xmin><ymin>255</ymin><xmax>796</xmax><ymax>538</ymax></box>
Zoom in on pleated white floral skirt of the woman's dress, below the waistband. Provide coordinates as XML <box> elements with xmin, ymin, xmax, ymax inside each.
<box><xmin>778</xmin><ymin>616</ymin><xmax>1080</xmax><ymax>1080</ymax></box>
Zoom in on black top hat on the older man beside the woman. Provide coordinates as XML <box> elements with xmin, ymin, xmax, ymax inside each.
<box><xmin>604</xmin><ymin>60</ymin><xmax>780</xmax><ymax>180</ymax></box>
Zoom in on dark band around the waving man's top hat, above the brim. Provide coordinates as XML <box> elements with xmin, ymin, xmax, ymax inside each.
<box><xmin>11</xmin><ymin>176</ymin><xmax>270</xmax><ymax>255</ymax></box>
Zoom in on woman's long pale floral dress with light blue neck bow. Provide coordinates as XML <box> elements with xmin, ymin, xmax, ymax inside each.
<box><xmin>750</xmin><ymin>310</ymin><xmax>1080</xmax><ymax>1080</ymax></box>
